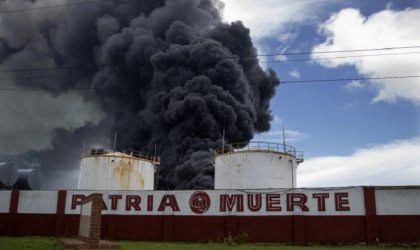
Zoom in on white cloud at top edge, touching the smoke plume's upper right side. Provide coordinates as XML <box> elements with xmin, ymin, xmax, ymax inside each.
<box><xmin>223</xmin><ymin>0</ymin><xmax>327</xmax><ymax>40</ymax></box>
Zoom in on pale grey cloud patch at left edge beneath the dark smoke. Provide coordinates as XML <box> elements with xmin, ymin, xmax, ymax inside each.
<box><xmin>0</xmin><ymin>92</ymin><xmax>105</xmax><ymax>155</ymax></box>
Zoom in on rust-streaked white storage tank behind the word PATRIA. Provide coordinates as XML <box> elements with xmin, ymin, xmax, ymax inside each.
<box><xmin>77</xmin><ymin>149</ymin><xmax>159</xmax><ymax>190</ymax></box>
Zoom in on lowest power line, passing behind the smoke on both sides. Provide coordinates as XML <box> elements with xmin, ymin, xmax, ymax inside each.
<box><xmin>0</xmin><ymin>75</ymin><xmax>420</xmax><ymax>91</ymax></box>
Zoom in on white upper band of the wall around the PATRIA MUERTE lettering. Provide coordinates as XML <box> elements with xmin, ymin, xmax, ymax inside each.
<box><xmin>0</xmin><ymin>187</ymin><xmax>420</xmax><ymax>216</ymax></box>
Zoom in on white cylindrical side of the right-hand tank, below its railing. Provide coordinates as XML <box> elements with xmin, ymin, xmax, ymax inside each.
<box><xmin>214</xmin><ymin>151</ymin><xmax>296</xmax><ymax>189</ymax></box>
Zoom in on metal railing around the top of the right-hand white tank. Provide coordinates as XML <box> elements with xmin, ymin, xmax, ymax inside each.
<box><xmin>216</xmin><ymin>141</ymin><xmax>303</xmax><ymax>161</ymax></box>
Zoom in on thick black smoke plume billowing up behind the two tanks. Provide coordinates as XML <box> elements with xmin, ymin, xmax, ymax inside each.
<box><xmin>0</xmin><ymin>0</ymin><xmax>278</xmax><ymax>189</ymax></box>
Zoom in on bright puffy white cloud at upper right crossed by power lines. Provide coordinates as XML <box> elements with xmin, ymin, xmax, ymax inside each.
<box><xmin>312</xmin><ymin>8</ymin><xmax>420</xmax><ymax>104</ymax></box>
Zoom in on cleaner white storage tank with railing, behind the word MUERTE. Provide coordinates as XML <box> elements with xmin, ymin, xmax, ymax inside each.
<box><xmin>214</xmin><ymin>142</ymin><xmax>303</xmax><ymax>189</ymax></box>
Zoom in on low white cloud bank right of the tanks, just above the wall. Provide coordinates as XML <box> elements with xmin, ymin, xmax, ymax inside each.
<box><xmin>298</xmin><ymin>137</ymin><xmax>420</xmax><ymax>187</ymax></box>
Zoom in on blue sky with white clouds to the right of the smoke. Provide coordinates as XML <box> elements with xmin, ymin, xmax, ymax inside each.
<box><xmin>224</xmin><ymin>0</ymin><xmax>420</xmax><ymax>186</ymax></box>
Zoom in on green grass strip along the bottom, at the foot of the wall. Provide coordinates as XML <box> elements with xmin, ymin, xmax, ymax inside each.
<box><xmin>0</xmin><ymin>237</ymin><xmax>420</xmax><ymax>250</ymax></box>
